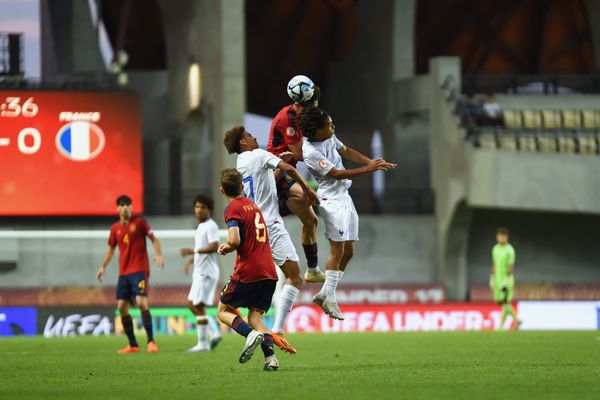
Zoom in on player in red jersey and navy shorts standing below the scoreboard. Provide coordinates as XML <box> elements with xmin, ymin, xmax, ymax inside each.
<box><xmin>96</xmin><ymin>195</ymin><xmax>164</xmax><ymax>354</ymax></box>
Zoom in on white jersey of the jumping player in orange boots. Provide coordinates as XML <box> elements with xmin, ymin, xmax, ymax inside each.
<box><xmin>236</xmin><ymin>149</ymin><xmax>283</xmax><ymax>225</ymax></box>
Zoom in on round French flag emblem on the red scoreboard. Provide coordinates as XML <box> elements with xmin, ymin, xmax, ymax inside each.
<box><xmin>56</xmin><ymin>121</ymin><xmax>105</xmax><ymax>161</ymax></box>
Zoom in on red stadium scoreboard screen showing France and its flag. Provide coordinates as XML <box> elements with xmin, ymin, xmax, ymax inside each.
<box><xmin>0</xmin><ymin>90</ymin><xmax>144</xmax><ymax>216</ymax></box>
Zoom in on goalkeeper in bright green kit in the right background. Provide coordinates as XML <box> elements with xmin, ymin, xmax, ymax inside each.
<box><xmin>490</xmin><ymin>228</ymin><xmax>521</xmax><ymax>329</ymax></box>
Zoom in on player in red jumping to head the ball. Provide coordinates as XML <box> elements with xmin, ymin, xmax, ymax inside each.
<box><xmin>267</xmin><ymin>78</ymin><xmax>325</xmax><ymax>283</ymax></box>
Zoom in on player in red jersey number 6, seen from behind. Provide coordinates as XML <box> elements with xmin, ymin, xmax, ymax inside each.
<box><xmin>217</xmin><ymin>168</ymin><xmax>279</xmax><ymax>371</ymax></box>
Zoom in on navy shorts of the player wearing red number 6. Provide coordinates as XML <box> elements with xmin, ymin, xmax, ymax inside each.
<box><xmin>221</xmin><ymin>278</ymin><xmax>277</xmax><ymax>312</ymax></box>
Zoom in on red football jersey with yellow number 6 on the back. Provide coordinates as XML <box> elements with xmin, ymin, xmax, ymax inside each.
<box><xmin>225</xmin><ymin>197</ymin><xmax>277</xmax><ymax>282</ymax></box>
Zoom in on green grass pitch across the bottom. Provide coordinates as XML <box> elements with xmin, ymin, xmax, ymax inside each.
<box><xmin>0</xmin><ymin>331</ymin><xmax>600</xmax><ymax>400</ymax></box>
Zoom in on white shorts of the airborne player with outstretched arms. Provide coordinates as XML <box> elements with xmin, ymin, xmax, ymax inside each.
<box><xmin>319</xmin><ymin>192</ymin><xmax>358</xmax><ymax>242</ymax></box>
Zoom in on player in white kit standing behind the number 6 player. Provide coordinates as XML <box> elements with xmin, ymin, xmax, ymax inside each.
<box><xmin>179</xmin><ymin>194</ymin><xmax>221</xmax><ymax>352</ymax></box>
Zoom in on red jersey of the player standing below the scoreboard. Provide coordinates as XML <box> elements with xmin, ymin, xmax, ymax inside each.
<box><xmin>108</xmin><ymin>217</ymin><xmax>154</xmax><ymax>275</ymax></box>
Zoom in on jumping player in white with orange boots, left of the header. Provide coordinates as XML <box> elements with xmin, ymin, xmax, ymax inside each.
<box><xmin>223</xmin><ymin>126</ymin><xmax>319</xmax><ymax>353</ymax></box>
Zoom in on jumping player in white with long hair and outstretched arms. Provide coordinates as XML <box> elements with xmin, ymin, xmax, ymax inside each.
<box><xmin>296</xmin><ymin>107</ymin><xmax>396</xmax><ymax>320</ymax></box>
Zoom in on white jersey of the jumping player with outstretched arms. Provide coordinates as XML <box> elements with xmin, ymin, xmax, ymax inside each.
<box><xmin>302</xmin><ymin>135</ymin><xmax>352</xmax><ymax>198</ymax></box>
